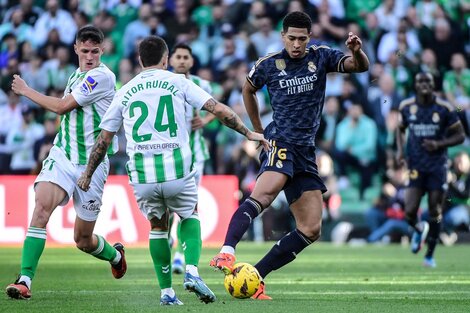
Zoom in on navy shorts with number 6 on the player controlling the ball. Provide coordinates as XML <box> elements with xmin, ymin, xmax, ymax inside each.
<box><xmin>259</xmin><ymin>140</ymin><xmax>327</xmax><ymax>204</ymax></box>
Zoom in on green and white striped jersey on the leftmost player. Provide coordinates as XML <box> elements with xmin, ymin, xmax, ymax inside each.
<box><xmin>54</xmin><ymin>63</ymin><xmax>118</xmax><ymax>164</ymax></box>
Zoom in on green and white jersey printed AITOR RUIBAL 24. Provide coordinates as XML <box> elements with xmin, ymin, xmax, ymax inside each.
<box><xmin>100</xmin><ymin>69</ymin><xmax>211</xmax><ymax>184</ymax></box>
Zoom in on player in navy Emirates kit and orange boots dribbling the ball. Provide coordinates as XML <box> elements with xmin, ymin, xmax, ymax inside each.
<box><xmin>210</xmin><ymin>12</ymin><xmax>369</xmax><ymax>299</ymax></box>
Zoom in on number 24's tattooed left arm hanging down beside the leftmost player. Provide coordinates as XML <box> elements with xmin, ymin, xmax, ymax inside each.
<box><xmin>77</xmin><ymin>129</ymin><xmax>115</xmax><ymax>191</ymax></box>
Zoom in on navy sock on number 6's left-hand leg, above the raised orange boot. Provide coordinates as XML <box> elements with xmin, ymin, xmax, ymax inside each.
<box><xmin>224</xmin><ymin>197</ymin><xmax>263</xmax><ymax>248</ymax></box>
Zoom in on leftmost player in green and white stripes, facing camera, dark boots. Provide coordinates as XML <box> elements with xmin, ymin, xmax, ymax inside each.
<box><xmin>6</xmin><ymin>26</ymin><xmax>127</xmax><ymax>299</ymax></box>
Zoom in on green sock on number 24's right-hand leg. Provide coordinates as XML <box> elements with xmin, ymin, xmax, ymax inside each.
<box><xmin>181</xmin><ymin>215</ymin><xmax>202</xmax><ymax>266</ymax></box>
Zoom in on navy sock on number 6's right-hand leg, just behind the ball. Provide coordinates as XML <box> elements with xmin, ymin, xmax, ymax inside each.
<box><xmin>255</xmin><ymin>229</ymin><xmax>313</xmax><ymax>278</ymax></box>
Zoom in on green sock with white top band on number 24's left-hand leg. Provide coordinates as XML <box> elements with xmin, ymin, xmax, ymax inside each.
<box><xmin>149</xmin><ymin>230</ymin><xmax>171</xmax><ymax>289</ymax></box>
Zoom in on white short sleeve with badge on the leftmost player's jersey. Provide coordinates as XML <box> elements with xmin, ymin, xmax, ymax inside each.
<box><xmin>72</xmin><ymin>69</ymin><xmax>114</xmax><ymax>107</ymax></box>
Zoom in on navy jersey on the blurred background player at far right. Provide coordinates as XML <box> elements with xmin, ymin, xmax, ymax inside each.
<box><xmin>399</xmin><ymin>97</ymin><xmax>459</xmax><ymax>172</ymax></box>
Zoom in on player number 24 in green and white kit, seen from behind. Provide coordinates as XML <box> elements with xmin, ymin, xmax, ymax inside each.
<box><xmin>78</xmin><ymin>36</ymin><xmax>269</xmax><ymax>305</ymax></box>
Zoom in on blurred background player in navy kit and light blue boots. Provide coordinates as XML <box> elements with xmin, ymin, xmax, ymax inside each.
<box><xmin>397</xmin><ymin>73</ymin><xmax>465</xmax><ymax>267</ymax></box>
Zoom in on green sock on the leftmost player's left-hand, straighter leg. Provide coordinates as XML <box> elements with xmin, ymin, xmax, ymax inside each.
<box><xmin>21</xmin><ymin>227</ymin><xmax>47</xmax><ymax>279</ymax></box>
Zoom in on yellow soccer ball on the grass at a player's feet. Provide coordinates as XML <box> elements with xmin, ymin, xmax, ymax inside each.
<box><xmin>224</xmin><ymin>263</ymin><xmax>261</xmax><ymax>299</ymax></box>
